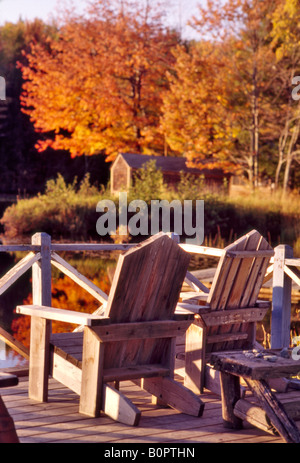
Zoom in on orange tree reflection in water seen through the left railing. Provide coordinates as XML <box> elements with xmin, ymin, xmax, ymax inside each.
<box><xmin>0</xmin><ymin>253</ymin><xmax>116</xmax><ymax>346</ymax></box>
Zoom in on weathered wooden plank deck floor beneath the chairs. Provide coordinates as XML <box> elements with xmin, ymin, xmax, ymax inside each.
<box><xmin>0</xmin><ymin>370</ymin><xmax>283</xmax><ymax>447</ymax></box>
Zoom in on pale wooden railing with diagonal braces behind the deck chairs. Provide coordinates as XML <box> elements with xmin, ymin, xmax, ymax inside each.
<box><xmin>0</xmin><ymin>233</ymin><xmax>300</xmax><ymax>359</ymax></box>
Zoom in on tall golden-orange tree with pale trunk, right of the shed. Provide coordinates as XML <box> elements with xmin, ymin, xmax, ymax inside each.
<box><xmin>163</xmin><ymin>0</ymin><xmax>280</xmax><ymax>186</ymax></box>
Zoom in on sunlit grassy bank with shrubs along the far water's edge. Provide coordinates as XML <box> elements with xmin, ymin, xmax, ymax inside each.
<box><xmin>1</xmin><ymin>172</ymin><xmax>300</xmax><ymax>255</ymax></box>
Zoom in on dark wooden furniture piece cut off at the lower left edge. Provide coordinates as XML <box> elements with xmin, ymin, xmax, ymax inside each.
<box><xmin>0</xmin><ymin>372</ymin><xmax>19</xmax><ymax>444</ymax></box>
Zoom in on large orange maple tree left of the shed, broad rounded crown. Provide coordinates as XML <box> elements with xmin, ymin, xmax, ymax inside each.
<box><xmin>22</xmin><ymin>0</ymin><xmax>178</xmax><ymax>159</ymax></box>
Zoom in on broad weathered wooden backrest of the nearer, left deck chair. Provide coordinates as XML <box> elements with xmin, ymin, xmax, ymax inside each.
<box><xmin>104</xmin><ymin>233</ymin><xmax>190</xmax><ymax>368</ymax></box>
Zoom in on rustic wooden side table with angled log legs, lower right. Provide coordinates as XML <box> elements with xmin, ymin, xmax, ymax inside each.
<box><xmin>209</xmin><ymin>351</ymin><xmax>300</xmax><ymax>443</ymax></box>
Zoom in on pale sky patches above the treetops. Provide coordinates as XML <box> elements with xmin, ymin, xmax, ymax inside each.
<box><xmin>0</xmin><ymin>0</ymin><xmax>203</xmax><ymax>38</ymax></box>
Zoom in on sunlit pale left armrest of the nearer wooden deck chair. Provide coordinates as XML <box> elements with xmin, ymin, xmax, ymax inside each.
<box><xmin>16</xmin><ymin>305</ymin><xmax>110</xmax><ymax>326</ymax></box>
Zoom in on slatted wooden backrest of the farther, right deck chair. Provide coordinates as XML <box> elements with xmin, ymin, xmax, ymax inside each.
<box><xmin>206</xmin><ymin>230</ymin><xmax>272</xmax><ymax>352</ymax></box>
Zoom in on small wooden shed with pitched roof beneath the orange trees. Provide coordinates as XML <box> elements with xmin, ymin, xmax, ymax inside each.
<box><xmin>110</xmin><ymin>153</ymin><xmax>231</xmax><ymax>194</ymax></box>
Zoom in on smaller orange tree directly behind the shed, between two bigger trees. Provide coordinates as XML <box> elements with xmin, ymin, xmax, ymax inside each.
<box><xmin>161</xmin><ymin>42</ymin><xmax>234</xmax><ymax>171</ymax></box>
